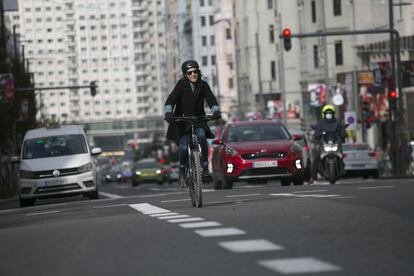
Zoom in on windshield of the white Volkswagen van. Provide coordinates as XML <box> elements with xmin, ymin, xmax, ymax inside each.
<box><xmin>23</xmin><ymin>134</ymin><xmax>88</xmax><ymax>159</ymax></box>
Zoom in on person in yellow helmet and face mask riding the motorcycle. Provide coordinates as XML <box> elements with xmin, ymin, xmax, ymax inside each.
<box><xmin>309</xmin><ymin>104</ymin><xmax>346</xmax><ymax>184</ymax></box>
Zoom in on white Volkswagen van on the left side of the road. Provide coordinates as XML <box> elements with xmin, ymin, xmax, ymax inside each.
<box><xmin>12</xmin><ymin>125</ymin><xmax>102</xmax><ymax>207</ymax></box>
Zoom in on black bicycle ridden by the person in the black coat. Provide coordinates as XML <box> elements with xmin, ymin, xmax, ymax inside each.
<box><xmin>174</xmin><ymin>115</ymin><xmax>214</xmax><ymax>208</ymax></box>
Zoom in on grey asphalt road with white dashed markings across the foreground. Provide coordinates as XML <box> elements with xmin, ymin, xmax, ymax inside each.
<box><xmin>0</xmin><ymin>179</ymin><xmax>414</xmax><ymax>276</ymax></box>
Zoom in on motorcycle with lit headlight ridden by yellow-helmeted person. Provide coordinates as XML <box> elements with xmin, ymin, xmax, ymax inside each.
<box><xmin>312</xmin><ymin>125</ymin><xmax>348</xmax><ymax>184</ymax></box>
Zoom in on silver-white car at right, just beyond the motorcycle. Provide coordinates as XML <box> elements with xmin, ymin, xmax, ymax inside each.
<box><xmin>342</xmin><ymin>143</ymin><xmax>380</xmax><ymax>178</ymax></box>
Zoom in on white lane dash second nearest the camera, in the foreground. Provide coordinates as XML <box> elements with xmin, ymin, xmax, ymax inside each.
<box><xmin>219</xmin><ymin>239</ymin><xmax>283</xmax><ymax>253</ymax></box>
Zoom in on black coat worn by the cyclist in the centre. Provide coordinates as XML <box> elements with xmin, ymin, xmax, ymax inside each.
<box><xmin>165</xmin><ymin>78</ymin><xmax>218</xmax><ymax>144</ymax></box>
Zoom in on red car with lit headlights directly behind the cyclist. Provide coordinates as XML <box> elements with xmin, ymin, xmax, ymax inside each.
<box><xmin>212</xmin><ymin>121</ymin><xmax>304</xmax><ymax>189</ymax></box>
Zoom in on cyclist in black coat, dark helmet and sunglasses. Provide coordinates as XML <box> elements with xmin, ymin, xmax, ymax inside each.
<box><xmin>164</xmin><ymin>60</ymin><xmax>221</xmax><ymax>185</ymax></box>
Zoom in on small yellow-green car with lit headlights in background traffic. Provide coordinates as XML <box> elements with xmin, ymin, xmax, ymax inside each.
<box><xmin>132</xmin><ymin>158</ymin><xmax>166</xmax><ymax>186</ymax></box>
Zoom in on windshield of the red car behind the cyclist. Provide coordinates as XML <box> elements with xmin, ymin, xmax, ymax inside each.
<box><xmin>228</xmin><ymin>124</ymin><xmax>289</xmax><ymax>142</ymax></box>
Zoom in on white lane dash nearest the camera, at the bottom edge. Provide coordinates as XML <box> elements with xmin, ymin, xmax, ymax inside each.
<box><xmin>258</xmin><ymin>257</ymin><xmax>342</xmax><ymax>274</ymax></box>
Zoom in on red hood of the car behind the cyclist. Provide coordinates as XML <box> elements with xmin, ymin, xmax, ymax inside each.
<box><xmin>227</xmin><ymin>140</ymin><xmax>294</xmax><ymax>153</ymax></box>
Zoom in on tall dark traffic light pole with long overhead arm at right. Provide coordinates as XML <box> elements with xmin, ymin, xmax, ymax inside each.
<box><xmin>279</xmin><ymin>28</ymin><xmax>407</xmax><ymax>175</ymax></box>
